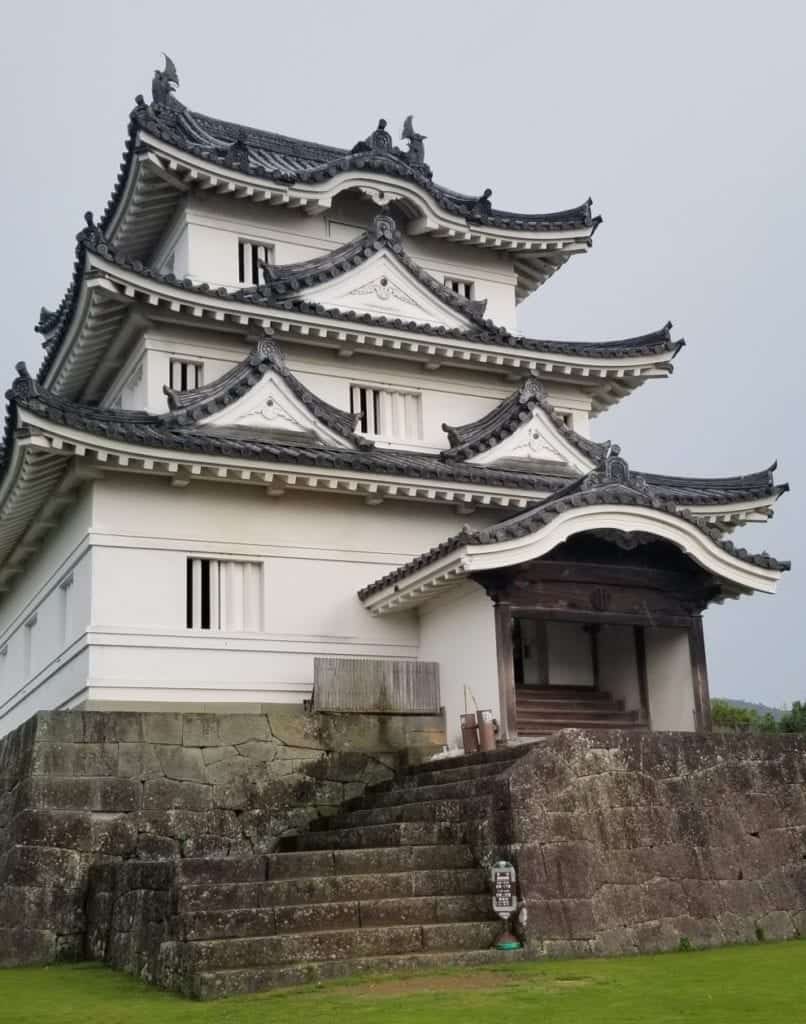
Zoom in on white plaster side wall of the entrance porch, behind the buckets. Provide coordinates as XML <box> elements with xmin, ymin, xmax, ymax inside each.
<box><xmin>420</xmin><ymin>582</ymin><xmax>501</xmax><ymax>746</ymax></box>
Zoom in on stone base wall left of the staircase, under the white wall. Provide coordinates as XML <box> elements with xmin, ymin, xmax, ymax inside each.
<box><xmin>0</xmin><ymin>706</ymin><xmax>444</xmax><ymax>965</ymax></box>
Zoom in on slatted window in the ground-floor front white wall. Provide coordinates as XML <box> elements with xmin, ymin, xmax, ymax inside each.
<box><xmin>185</xmin><ymin>558</ymin><xmax>263</xmax><ymax>633</ymax></box>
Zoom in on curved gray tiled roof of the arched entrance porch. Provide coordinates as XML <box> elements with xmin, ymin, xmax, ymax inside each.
<box><xmin>358</xmin><ymin>445</ymin><xmax>791</xmax><ymax>600</ymax></box>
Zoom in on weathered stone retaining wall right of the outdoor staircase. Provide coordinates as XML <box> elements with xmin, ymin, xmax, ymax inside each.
<box><xmin>510</xmin><ymin>730</ymin><xmax>806</xmax><ymax>956</ymax></box>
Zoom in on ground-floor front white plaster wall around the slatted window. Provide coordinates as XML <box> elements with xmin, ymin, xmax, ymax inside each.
<box><xmin>85</xmin><ymin>474</ymin><xmax>491</xmax><ymax>701</ymax></box>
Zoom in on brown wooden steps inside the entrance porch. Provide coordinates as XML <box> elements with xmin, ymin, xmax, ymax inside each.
<box><xmin>515</xmin><ymin>686</ymin><xmax>646</xmax><ymax>737</ymax></box>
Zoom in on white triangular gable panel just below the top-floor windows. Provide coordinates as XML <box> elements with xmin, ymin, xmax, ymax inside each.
<box><xmin>300</xmin><ymin>251</ymin><xmax>472</xmax><ymax>331</ymax></box>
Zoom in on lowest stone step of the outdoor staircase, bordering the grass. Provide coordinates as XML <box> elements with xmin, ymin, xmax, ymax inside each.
<box><xmin>186</xmin><ymin>942</ymin><xmax>535</xmax><ymax>999</ymax></box>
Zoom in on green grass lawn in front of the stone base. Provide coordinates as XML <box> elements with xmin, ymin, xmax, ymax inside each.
<box><xmin>0</xmin><ymin>940</ymin><xmax>806</xmax><ymax>1024</ymax></box>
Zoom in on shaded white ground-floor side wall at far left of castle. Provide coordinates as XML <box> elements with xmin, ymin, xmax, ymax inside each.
<box><xmin>0</xmin><ymin>487</ymin><xmax>92</xmax><ymax>735</ymax></box>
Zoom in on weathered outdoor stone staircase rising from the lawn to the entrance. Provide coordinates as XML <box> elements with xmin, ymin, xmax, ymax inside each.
<box><xmin>111</xmin><ymin>746</ymin><xmax>527</xmax><ymax>998</ymax></box>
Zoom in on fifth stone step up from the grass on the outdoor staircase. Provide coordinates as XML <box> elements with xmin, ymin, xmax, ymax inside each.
<box><xmin>266</xmin><ymin>844</ymin><xmax>474</xmax><ymax>882</ymax></box>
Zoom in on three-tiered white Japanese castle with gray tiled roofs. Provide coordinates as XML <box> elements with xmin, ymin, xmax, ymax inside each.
<box><xmin>0</xmin><ymin>61</ymin><xmax>788</xmax><ymax>745</ymax></box>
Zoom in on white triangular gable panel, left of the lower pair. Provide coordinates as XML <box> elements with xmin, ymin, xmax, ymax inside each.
<box><xmin>201</xmin><ymin>371</ymin><xmax>351</xmax><ymax>449</ymax></box>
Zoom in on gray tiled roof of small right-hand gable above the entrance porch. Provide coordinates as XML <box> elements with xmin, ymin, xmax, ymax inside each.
<box><xmin>442</xmin><ymin>377</ymin><xmax>607</xmax><ymax>461</ymax></box>
